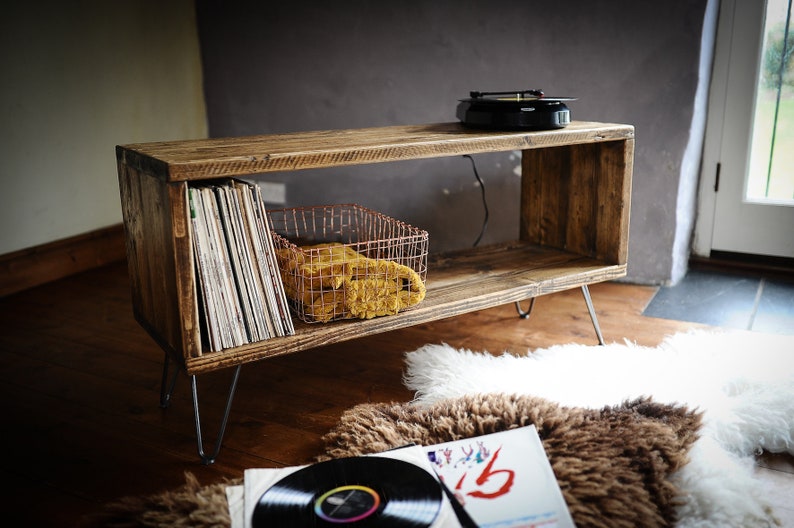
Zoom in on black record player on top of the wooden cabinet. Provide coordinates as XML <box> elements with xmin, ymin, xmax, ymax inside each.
<box><xmin>457</xmin><ymin>90</ymin><xmax>576</xmax><ymax>130</ymax></box>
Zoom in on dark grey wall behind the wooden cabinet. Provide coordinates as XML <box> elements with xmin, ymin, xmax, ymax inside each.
<box><xmin>197</xmin><ymin>0</ymin><xmax>708</xmax><ymax>283</ymax></box>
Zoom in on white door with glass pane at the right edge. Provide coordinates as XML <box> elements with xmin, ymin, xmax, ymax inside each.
<box><xmin>693</xmin><ymin>0</ymin><xmax>794</xmax><ymax>258</ymax></box>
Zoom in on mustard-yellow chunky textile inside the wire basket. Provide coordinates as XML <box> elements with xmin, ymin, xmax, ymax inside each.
<box><xmin>278</xmin><ymin>244</ymin><xmax>426</xmax><ymax>322</ymax></box>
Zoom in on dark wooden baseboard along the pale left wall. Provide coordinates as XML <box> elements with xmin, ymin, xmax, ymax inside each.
<box><xmin>0</xmin><ymin>224</ymin><xmax>126</xmax><ymax>297</ymax></box>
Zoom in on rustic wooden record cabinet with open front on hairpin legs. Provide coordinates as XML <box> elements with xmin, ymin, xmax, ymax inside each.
<box><xmin>116</xmin><ymin>121</ymin><xmax>634</xmax><ymax>462</ymax></box>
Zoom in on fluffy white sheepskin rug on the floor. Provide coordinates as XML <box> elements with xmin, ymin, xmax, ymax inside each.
<box><xmin>405</xmin><ymin>331</ymin><xmax>794</xmax><ymax>528</ymax></box>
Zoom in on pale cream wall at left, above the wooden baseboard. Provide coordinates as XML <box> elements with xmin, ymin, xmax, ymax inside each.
<box><xmin>0</xmin><ymin>0</ymin><xmax>207</xmax><ymax>255</ymax></box>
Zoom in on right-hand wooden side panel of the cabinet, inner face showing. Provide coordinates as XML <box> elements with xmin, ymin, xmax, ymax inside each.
<box><xmin>520</xmin><ymin>140</ymin><xmax>634</xmax><ymax>264</ymax></box>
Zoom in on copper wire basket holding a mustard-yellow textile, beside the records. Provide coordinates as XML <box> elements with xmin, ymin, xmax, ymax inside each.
<box><xmin>268</xmin><ymin>204</ymin><xmax>428</xmax><ymax>323</ymax></box>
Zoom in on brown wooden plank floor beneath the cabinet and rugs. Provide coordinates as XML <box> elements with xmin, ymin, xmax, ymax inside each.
<box><xmin>0</xmin><ymin>264</ymin><xmax>794</xmax><ymax>526</ymax></box>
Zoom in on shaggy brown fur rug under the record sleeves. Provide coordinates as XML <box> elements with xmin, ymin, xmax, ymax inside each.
<box><xmin>84</xmin><ymin>394</ymin><xmax>701</xmax><ymax>528</ymax></box>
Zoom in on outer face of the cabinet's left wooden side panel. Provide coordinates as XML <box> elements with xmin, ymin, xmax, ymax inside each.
<box><xmin>118</xmin><ymin>163</ymin><xmax>183</xmax><ymax>366</ymax></box>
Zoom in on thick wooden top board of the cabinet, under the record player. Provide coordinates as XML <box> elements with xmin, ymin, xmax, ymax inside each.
<box><xmin>116</xmin><ymin>121</ymin><xmax>634</xmax><ymax>182</ymax></box>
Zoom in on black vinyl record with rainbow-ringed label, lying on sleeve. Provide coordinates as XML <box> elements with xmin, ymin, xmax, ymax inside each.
<box><xmin>252</xmin><ymin>456</ymin><xmax>442</xmax><ymax>528</ymax></box>
